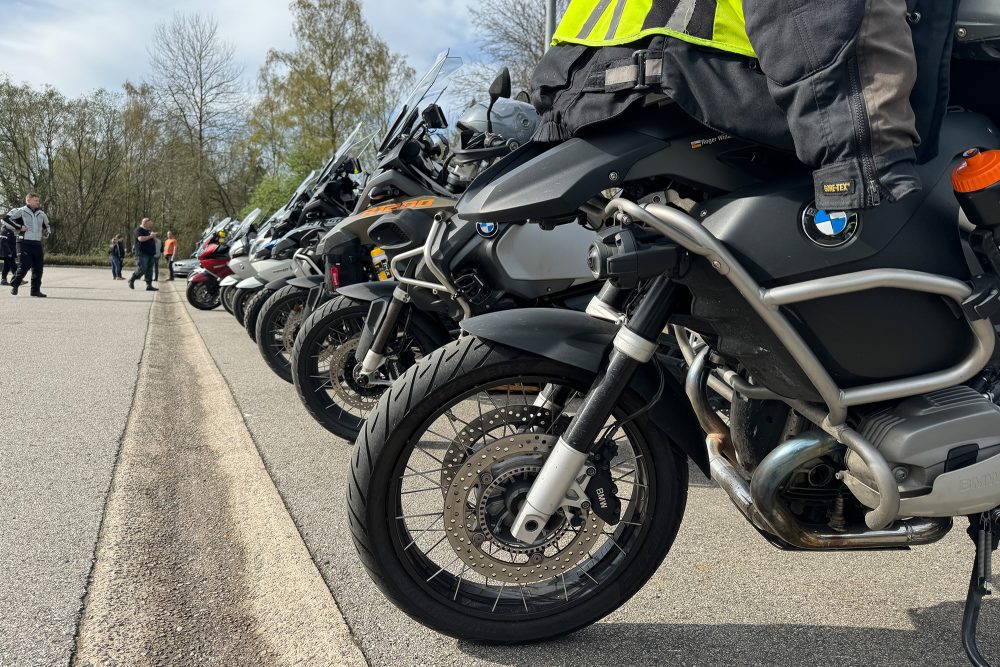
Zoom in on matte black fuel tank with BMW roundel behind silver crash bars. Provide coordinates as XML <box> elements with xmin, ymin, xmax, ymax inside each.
<box><xmin>679</xmin><ymin>113</ymin><xmax>1000</xmax><ymax>400</ymax></box>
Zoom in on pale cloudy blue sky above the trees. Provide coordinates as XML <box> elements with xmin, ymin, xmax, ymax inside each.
<box><xmin>0</xmin><ymin>0</ymin><xmax>476</xmax><ymax>96</ymax></box>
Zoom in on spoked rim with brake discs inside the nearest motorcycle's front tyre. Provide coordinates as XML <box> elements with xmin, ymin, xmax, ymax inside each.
<box><xmin>387</xmin><ymin>375</ymin><xmax>655</xmax><ymax>620</ymax></box>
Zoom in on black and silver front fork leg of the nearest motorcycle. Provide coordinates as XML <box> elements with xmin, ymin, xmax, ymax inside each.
<box><xmin>511</xmin><ymin>276</ymin><xmax>675</xmax><ymax>544</ymax></box>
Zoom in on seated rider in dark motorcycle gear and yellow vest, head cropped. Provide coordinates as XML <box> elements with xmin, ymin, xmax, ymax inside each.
<box><xmin>532</xmin><ymin>0</ymin><xmax>958</xmax><ymax>210</ymax></box>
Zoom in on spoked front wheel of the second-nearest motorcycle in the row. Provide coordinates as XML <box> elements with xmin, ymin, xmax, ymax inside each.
<box><xmin>292</xmin><ymin>296</ymin><xmax>436</xmax><ymax>442</ymax></box>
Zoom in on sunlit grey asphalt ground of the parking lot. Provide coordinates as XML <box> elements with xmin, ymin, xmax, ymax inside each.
<box><xmin>0</xmin><ymin>269</ymin><xmax>1000</xmax><ymax>666</ymax></box>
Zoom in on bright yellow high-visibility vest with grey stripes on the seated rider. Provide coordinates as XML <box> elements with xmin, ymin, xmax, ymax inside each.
<box><xmin>552</xmin><ymin>0</ymin><xmax>756</xmax><ymax>58</ymax></box>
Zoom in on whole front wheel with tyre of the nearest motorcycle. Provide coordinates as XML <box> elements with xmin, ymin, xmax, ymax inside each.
<box><xmin>348</xmin><ymin>337</ymin><xmax>687</xmax><ymax>643</ymax></box>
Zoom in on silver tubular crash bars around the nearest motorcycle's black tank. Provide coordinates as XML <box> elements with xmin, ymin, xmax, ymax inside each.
<box><xmin>605</xmin><ymin>199</ymin><xmax>996</xmax><ymax>529</ymax></box>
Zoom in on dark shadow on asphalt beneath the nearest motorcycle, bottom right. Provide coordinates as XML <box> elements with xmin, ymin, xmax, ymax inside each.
<box><xmin>458</xmin><ymin>602</ymin><xmax>1000</xmax><ymax>667</ymax></box>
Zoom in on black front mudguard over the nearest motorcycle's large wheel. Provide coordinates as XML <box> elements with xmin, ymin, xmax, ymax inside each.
<box><xmin>461</xmin><ymin>308</ymin><xmax>711</xmax><ymax>476</ymax></box>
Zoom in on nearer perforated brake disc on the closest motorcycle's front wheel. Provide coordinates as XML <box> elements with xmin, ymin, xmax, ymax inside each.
<box><xmin>444</xmin><ymin>433</ymin><xmax>604</xmax><ymax>584</ymax></box>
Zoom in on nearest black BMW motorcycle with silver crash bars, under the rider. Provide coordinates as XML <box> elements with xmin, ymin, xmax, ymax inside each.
<box><xmin>348</xmin><ymin>4</ymin><xmax>1000</xmax><ymax>665</ymax></box>
